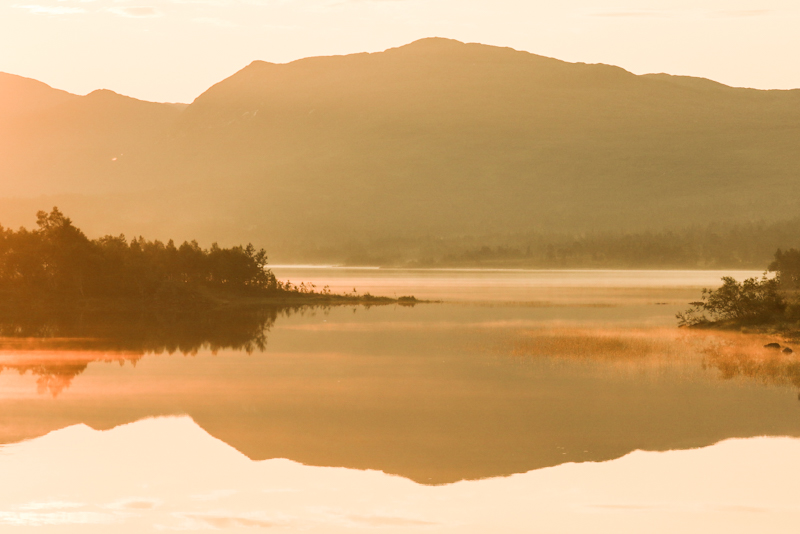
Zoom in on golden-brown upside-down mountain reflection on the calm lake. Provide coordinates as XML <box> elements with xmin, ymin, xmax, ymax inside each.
<box><xmin>0</xmin><ymin>320</ymin><xmax>800</xmax><ymax>483</ymax></box>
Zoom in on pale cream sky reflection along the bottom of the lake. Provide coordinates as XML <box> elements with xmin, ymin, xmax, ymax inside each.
<box><xmin>0</xmin><ymin>417</ymin><xmax>800</xmax><ymax>534</ymax></box>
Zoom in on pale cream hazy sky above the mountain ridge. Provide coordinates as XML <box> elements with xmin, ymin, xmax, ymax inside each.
<box><xmin>0</xmin><ymin>0</ymin><xmax>800</xmax><ymax>102</ymax></box>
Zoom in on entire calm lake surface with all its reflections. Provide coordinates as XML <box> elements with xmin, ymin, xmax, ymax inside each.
<box><xmin>0</xmin><ymin>266</ymin><xmax>800</xmax><ymax>533</ymax></box>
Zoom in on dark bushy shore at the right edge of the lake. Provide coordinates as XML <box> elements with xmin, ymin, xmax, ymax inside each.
<box><xmin>676</xmin><ymin>249</ymin><xmax>800</xmax><ymax>340</ymax></box>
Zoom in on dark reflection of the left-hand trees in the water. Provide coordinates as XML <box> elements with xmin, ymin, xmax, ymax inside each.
<box><xmin>0</xmin><ymin>306</ymin><xmax>316</xmax><ymax>397</ymax></box>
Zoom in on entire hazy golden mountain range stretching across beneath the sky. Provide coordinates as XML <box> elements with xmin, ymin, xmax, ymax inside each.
<box><xmin>0</xmin><ymin>39</ymin><xmax>800</xmax><ymax>261</ymax></box>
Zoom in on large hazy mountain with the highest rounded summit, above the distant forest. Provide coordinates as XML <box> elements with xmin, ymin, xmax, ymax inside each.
<box><xmin>170</xmin><ymin>40</ymin><xmax>800</xmax><ymax>244</ymax></box>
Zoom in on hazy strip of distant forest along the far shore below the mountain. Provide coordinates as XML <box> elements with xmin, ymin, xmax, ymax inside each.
<box><xmin>332</xmin><ymin>218</ymin><xmax>800</xmax><ymax>270</ymax></box>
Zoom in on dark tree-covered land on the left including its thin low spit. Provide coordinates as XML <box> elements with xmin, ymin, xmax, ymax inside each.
<box><xmin>0</xmin><ymin>208</ymin><xmax>412</xmax><ymax>316</ymax></box>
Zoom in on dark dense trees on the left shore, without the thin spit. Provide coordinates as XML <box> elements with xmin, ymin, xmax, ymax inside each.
<box><xmin>0</xmin><ymin>208</ymin><xmax>288</xmax><ymax>306</ymax></box>
